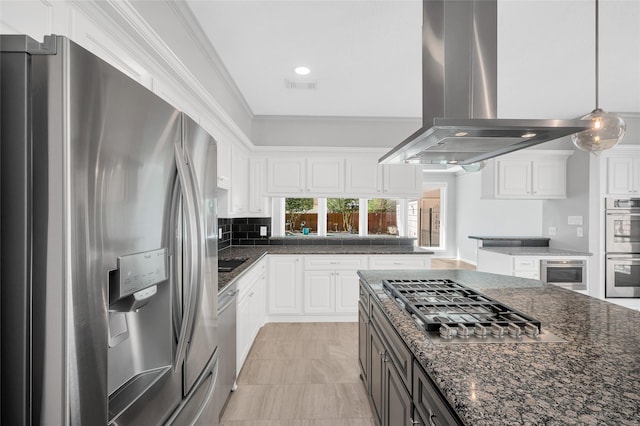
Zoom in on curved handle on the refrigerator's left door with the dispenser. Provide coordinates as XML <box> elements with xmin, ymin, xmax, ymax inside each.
<box><xmin>174</xmin><ymin>143</ymin><xmax>200</xmax><ymax>371</ymax></box>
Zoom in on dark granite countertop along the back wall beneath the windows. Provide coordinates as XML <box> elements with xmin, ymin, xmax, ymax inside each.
<box><xmin>218</xmin><ymin>244</ymin><xmax>433</xmax><ymax>292</ymax></box>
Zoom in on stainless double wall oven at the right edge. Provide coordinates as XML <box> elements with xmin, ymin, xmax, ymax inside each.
<box><xmin>605</xmin><ymin>197</ymin><xmax>640</xmax><ymax>297</ymax></box>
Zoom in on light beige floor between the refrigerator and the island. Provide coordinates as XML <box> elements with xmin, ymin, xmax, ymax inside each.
<box><xmin>221</xmin><ymin>323</ymin><xmax>375</xmax><ymax>426</ymax></box>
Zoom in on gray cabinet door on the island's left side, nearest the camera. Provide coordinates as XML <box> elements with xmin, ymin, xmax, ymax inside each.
<box><xmin>382</xmin><ymin>361</ymin><xmax>413</xmax><ymax>426</ymax></box>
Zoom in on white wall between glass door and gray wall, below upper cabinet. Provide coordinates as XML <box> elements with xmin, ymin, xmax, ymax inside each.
<box><xmin>455</xmin><ymin>173</ymin><xmax>542</xmax><ymax>264</ymax></box>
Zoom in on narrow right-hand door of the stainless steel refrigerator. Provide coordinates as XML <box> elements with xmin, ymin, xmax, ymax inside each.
<box><xmin>182</xmin><ymin>114</ymin><xmax>218</xmax><ymax>393</ymax></box>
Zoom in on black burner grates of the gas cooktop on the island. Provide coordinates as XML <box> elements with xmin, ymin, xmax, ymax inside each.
<box><xmin>382</xmin><ymin>279</ymin><xmax>541</xmax><ymax>331</ymax></box>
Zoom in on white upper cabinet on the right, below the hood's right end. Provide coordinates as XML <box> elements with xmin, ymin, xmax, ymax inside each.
<box><xmin>482</xmin><ymin>150</ymin><xmax>573</xmax><ymax>200</ymax></box>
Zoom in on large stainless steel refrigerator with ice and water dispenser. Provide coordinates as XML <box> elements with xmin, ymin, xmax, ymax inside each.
<box><xmin>0</xmin><ymin>35</ymin><xmax>218</xmax><ymax>425</ymax></box>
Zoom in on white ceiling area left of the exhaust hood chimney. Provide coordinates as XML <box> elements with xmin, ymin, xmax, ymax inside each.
<box><xmin>187</xmin><ymin>0</ymin><xmax>422</xmax><ymax>118</ymax></box>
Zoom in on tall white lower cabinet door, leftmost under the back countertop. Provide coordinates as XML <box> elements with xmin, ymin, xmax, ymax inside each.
<box><xmin>268</xmin><ymin>255</ymin><xmax>302</xmax><ymax>314</ymax></box>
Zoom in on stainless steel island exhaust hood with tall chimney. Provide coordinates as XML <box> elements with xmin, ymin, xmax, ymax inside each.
<box><xmin>379</xmin><ymin>0</ymin><xmax>589</xmax><ymax>165</ymax></box>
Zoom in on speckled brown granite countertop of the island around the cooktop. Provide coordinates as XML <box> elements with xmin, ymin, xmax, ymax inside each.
<box><xmin>359</xmin><ymin>270</ymin><xmax>640</xmax><ymax>426</ymax></box>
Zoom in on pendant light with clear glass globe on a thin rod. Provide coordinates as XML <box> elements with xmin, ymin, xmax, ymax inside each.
<box><xmin>571</xmin><ymin>0</ymin><xmax>626</xmax><ymax>154</ymax></box>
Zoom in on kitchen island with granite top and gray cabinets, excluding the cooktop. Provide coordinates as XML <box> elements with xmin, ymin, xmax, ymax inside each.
<box><xmin>358</xmin><ymin>270</ymin><xmax>640</xmax><ymax>426</ymax></box>
